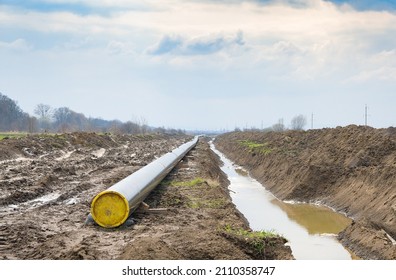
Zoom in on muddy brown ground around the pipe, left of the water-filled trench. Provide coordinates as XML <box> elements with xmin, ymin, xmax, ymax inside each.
<box><xmin>0</xmin><ymin>133</ymin><xmax>291</xmax><ymax>259</ymax></box>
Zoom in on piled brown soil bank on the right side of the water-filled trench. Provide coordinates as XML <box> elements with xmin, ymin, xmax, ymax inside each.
<box><xmin>216</xmin><ymin>126</ymin><xmax>396</xmax><ymax>259</ymax></box>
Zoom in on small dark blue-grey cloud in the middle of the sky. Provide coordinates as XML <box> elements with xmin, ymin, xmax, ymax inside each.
<box><xmin>147</xmin><ymin>32</ymin><xmax>244</xmax><ymax>55</ymax></box>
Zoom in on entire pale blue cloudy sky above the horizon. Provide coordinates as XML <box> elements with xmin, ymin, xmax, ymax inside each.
<box><xmin>0</xmin><ymin>0</ymin><xmax>396</xmax><ymax>130</ymax></box>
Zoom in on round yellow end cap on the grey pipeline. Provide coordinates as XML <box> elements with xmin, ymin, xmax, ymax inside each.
<box><xmin>91</xmin><ymin>190</ymin><xmax>129</xmax><ymax>228</ymax></box>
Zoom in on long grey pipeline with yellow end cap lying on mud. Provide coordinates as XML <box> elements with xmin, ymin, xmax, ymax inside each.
<box><xmin>88</xmin><ymin>136</ymin><xmax>199</xmax><ymax>228</ymax></box>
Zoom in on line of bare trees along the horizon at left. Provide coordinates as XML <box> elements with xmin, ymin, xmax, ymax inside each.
<box><xmin>0</xmin><ymin>92</ymin><xmax>185</xmax><ymax>134</ymax></box>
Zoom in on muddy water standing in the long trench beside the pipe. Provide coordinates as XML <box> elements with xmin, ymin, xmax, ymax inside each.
<box><xmin>211</xmin><ymin>143</ymin><xmax>351</xmax><ymax>260</ymax></box>
